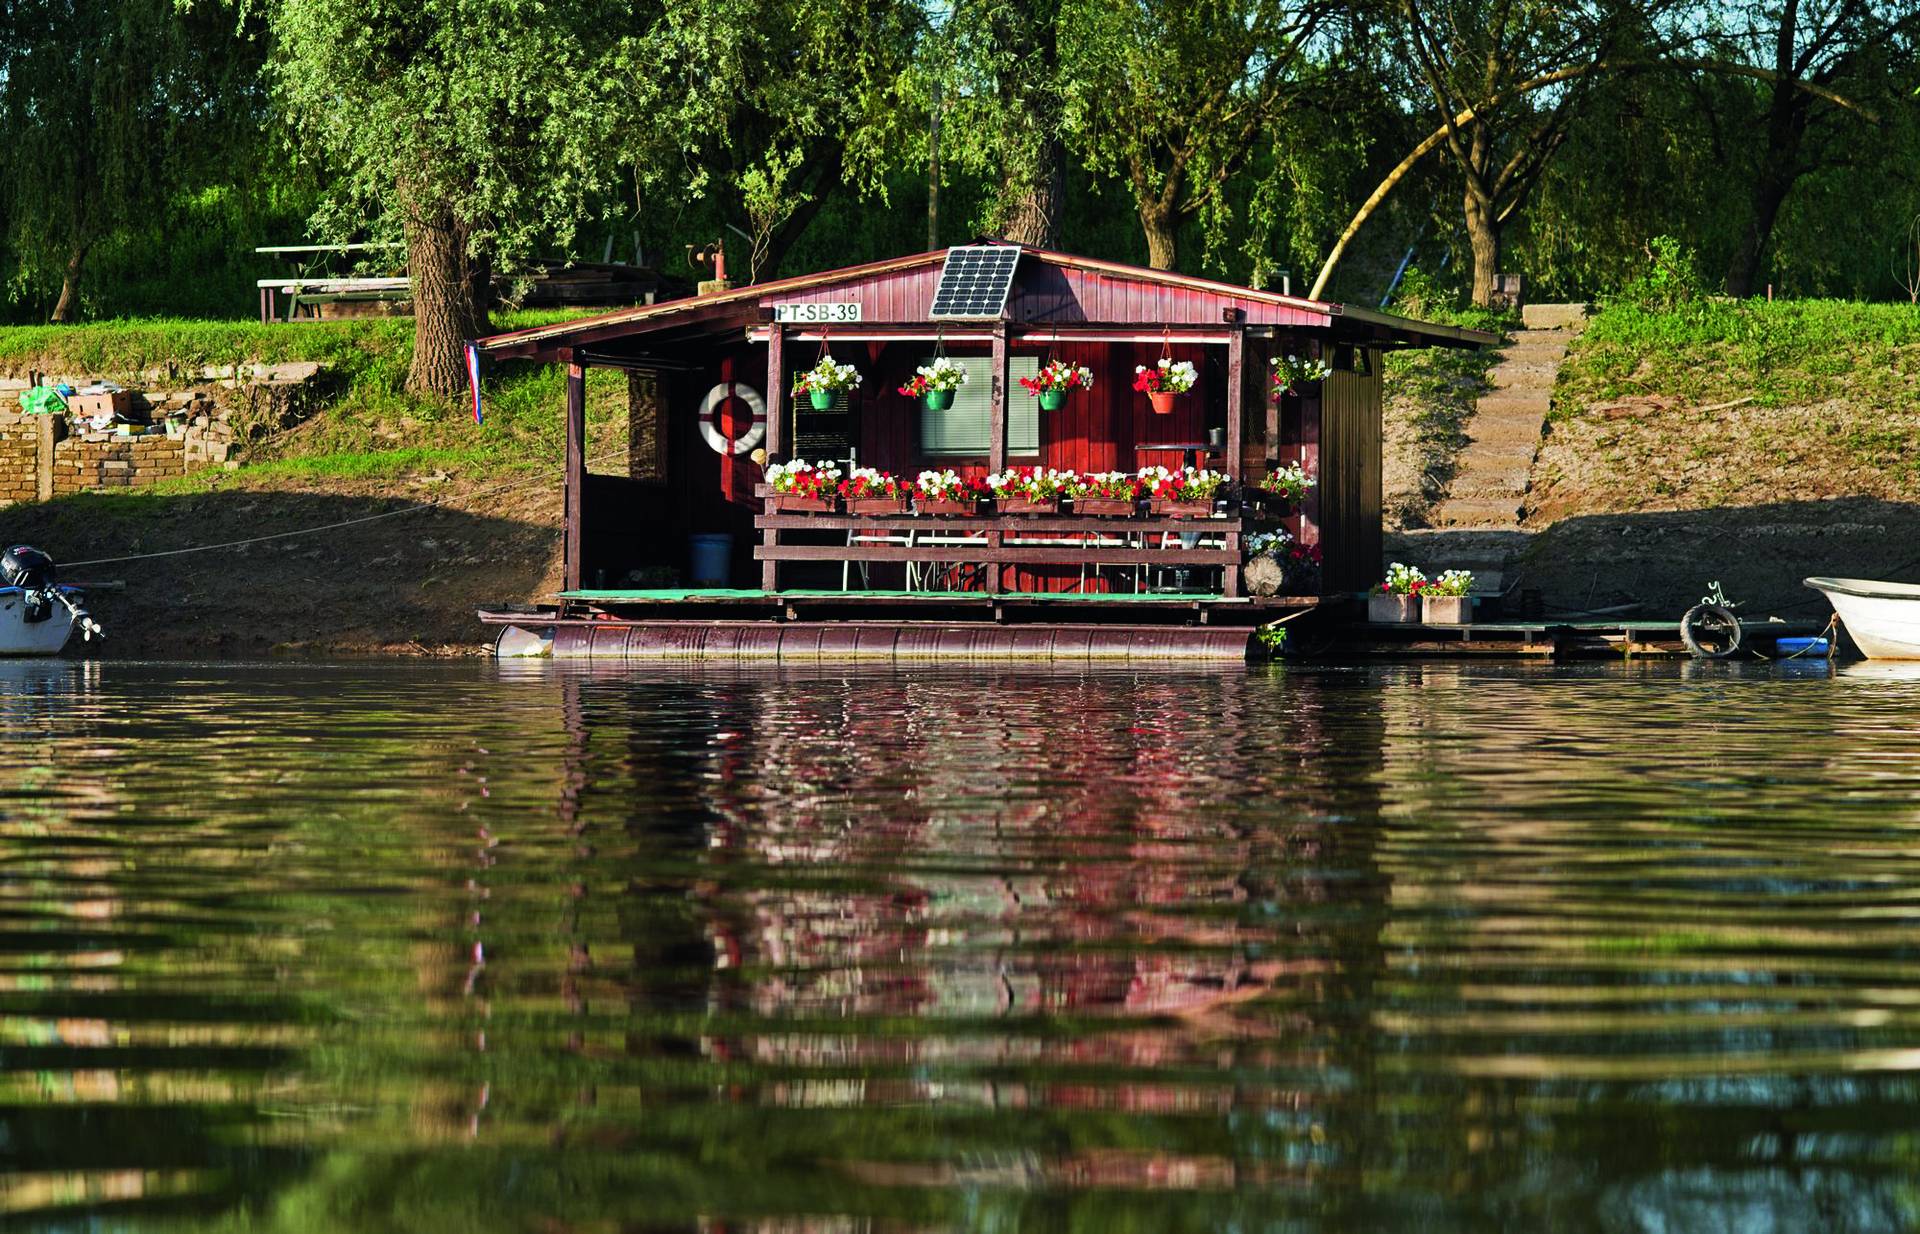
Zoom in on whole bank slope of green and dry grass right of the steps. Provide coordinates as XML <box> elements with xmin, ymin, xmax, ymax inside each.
<box><xmin>1528</xmin><ymin>299</ymin><xmax>1920</xmax><ymax>522</ymax></box>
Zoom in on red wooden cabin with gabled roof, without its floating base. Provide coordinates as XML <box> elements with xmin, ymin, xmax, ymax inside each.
<box><xmin>478</xmin><ymin>249</ymin><xmax>1494</xmax><ymax>640</ymax></box>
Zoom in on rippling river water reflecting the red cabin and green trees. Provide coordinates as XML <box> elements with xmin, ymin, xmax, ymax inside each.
<box><xmin>0</xmin><ymin>662</ymin><xmax>1920</xmax><ymax>1234</ymax></box>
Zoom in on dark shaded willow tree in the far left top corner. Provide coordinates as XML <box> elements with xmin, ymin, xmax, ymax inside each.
<box><xmin>0</xmin><ymin>0</ymin><xmax>265</xmax><ymax>322</ymax></box>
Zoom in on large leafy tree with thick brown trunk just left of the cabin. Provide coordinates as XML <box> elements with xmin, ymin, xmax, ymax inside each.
<box><xmin>269</xmin><ymin>0</ymin><xmax>664</xmax><ymax>395</ymax></box>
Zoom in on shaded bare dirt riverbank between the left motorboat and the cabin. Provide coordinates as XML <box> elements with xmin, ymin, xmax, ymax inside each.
<box><xmin>0</xmin><ymin>470</ymin><xmax>561</xmax><ymax>658</ymax></box>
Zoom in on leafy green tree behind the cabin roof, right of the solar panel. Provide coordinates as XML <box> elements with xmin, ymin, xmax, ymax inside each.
<box><xmin>1062</xmin><ymin>0</ymin><xmax>1344</xmax><ymax>271</ymax></box>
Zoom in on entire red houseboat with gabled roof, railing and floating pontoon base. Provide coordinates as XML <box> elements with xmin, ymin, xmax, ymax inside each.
<box><xmin>478</xmin><ymin>246</ymin><xmax>1494</xmax><ymax>654</ymax></box>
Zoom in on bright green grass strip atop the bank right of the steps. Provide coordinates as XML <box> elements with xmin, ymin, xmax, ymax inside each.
<box><xmin>1555</xmin><ymin>299</ymin><xmax>1920</xmax><ymax>416</ymax></box>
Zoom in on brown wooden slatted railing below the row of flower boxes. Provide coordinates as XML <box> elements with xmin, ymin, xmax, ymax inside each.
<box><xmin>753</xmin><ymin>514</ymin><xmax>1246</xmax><ymax>597</ymax></box>
